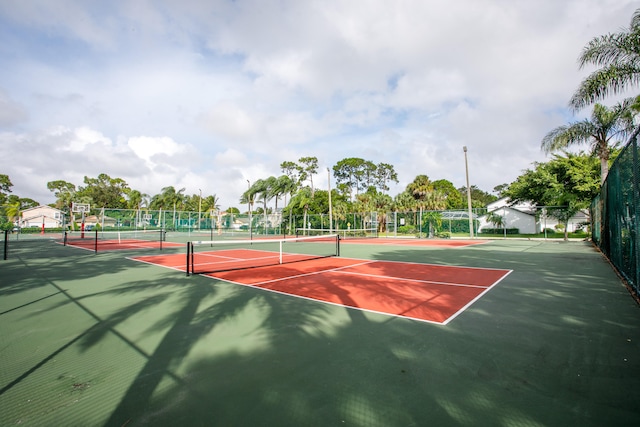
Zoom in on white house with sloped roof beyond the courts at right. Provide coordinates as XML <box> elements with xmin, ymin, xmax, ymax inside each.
<box><xmin>478</xmin><ymin>197</ymin><xmax>589</xmax><ymax>234</ymax></box>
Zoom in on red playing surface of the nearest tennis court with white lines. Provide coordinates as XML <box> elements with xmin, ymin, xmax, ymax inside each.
<box><xmin>131</xmin><ymin>249</ymin><xmax>511</xmax><ymax>325</ymax></box>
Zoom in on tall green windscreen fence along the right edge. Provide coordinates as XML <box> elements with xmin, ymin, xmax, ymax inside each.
<box><xmin>591</xmin><ymin>136</ymin><xmax>640</xmax><ymax>298</ymax></box>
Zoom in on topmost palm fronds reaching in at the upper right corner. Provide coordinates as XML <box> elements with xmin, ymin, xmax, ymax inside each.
<box><xmin>569</xmin><ymin>9</ymin><xmax>640</xmax><ymax>110</ymax></box>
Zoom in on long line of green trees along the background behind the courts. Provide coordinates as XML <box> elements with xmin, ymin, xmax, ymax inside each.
<box><xmin>0</xmin><ymin>157</ymin><xmax>497</xmax><ymax>231</ymax></box>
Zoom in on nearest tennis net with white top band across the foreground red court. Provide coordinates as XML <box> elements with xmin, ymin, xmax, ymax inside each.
<box><xmin>186</xmin><ymin>234</ymin><xmax>340</xmax><ymax>276</ymax></box>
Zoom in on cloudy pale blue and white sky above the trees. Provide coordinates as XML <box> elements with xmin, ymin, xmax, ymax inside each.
<box><xmin>0</xmin><ymin>0</ymin><xmax>640</xmax><ymax>209</ymax></box>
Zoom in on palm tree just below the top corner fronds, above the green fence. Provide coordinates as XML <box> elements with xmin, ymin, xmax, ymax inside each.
<box><xmin>542</xmin><ymin>103</ymin><xmax>634</xmax><ymax>183</ymax></box>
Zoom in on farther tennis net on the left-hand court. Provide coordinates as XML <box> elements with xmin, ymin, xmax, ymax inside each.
<box><xmin>64</xmin><ymin>229</ymin><xmax>165</xmax><ymax>252</ymax></box>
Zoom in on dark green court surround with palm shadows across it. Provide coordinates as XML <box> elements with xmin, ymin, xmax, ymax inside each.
<box><xmin>0</xmin><ymin>236</ymin><xmax>640</xmax><ymax>426</ymax></box>
